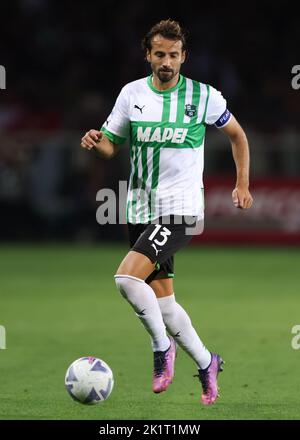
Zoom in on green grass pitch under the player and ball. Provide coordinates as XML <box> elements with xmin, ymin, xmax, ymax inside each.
<box><xmin>0</xmin><ymin>244</ymin><xmax>300</xmax><ymax>420</ymax></box>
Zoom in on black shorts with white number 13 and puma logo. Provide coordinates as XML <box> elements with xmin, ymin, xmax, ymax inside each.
<box><xmin>128</xmin><ymin>215</ymin><xmax>192</xmax><ymax>283</ymax></box>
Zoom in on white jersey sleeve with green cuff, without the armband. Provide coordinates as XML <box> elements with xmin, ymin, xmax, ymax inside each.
<box><xmin>101</xmin><ymin>86</ymin><xmax>130</xmax><ymax>144</ymax></box>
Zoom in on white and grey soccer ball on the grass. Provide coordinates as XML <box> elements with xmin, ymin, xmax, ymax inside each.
<box><xmin>65</xmin><ymin>357</ymin><xmax>114</xmax><ymax>405</ymax></box>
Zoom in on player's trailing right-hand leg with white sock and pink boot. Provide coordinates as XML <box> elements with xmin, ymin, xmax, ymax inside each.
<box><xmin>150</xmin><ymin>276</ymin><xmax>223</xmax><ymax>405</ymax></box>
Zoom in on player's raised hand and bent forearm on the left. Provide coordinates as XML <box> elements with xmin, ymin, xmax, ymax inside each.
<box><xmin>80</xmin><ymin>129</ymin><xmax>118</xmax><ymax>159</ymax></box>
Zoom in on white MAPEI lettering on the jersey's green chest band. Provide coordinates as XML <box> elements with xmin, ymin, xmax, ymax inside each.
<box><xmin>137</xmin><ymin>127</ymin><xmax>188</xmax><ymax>144</ymax></box>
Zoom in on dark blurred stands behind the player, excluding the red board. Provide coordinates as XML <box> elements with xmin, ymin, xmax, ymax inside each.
<box><xmin>0</xmin><ymin>0</ymin><xmax>300</xmax><ymax>239</ymax></box>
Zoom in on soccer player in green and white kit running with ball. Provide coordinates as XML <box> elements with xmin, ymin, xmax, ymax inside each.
<box><xmin>81</xmin><ymin>19</ymin><xmax>252</xmax><ymax>405</ymax></box>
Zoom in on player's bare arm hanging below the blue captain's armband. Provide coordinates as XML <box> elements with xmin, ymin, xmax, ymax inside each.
<box><xmin>220</xmin><ymin>115</ymin><xmax>253</xmax><ymax>209</ymax></box>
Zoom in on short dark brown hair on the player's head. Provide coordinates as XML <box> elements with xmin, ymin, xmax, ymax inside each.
<box><xmin>142</xmin><ymin>18</ymin><xmax>186</xmax><ymax>52</ymax></box>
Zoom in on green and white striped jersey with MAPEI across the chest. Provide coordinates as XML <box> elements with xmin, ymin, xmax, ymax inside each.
<box><xmin>101</xmin><ymin>75</ymin><xmax>226</xmax><ymax>224</ymax></box>
